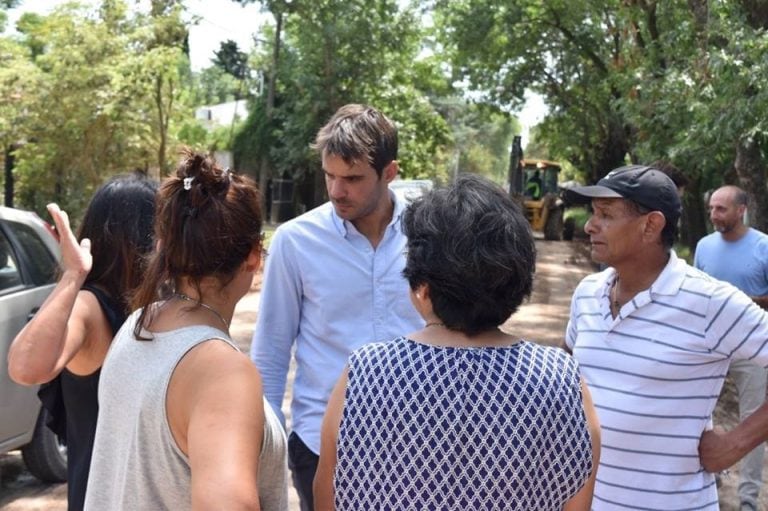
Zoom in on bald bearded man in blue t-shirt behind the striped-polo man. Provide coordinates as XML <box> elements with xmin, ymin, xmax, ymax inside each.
<box><xmin>694</xmin><ymin>186</ymin><xmax>768</xmax><ymax>511</ymax></box>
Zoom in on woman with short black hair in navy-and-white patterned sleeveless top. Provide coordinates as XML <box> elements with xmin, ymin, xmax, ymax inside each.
<box><xmin>315</xmin><ymin>176</ymin><xmax>600</xmax><ymax>511</ymax></box>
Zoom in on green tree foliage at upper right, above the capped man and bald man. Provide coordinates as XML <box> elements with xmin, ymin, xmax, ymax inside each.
<box><xmin>432</xmin><ymin>0</ymin><xmax>768</xmax><ymax>246</ymax></box>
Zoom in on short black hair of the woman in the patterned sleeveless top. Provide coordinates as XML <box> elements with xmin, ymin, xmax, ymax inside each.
<box><xmin>403</xmin><ymin>174</ymin><xmax>536</xmax><ymax>335</ymax></box>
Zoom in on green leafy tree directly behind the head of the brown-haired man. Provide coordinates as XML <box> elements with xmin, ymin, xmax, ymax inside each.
<box><xmin>231</xmin><ymin>0</ymin><xmax>450</xmax><ymax>210</ymax></box>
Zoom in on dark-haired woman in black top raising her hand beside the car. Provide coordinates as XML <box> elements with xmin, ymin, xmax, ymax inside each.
<box><xmin>8</xmin><ymin>174</ymin><xmax>157</xmax><ymax>511</ymax></box>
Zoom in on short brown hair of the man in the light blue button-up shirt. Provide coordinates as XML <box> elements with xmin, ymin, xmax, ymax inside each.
<box><xmin>313</xmin><ymin>104</ymin><xmax>398</xmax><ymax>177</ymax></box>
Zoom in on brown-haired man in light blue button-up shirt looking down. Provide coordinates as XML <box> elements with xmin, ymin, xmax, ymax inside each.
<box><xmin>251</xmin><ymin>104</ymin><xmax>423</xmax><ymax>511</ymax></box>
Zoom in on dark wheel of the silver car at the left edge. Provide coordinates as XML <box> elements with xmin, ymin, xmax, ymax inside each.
<box><xmin>21</xmin><ymin>408</ymin><xmax>67</xmax><ymax>483</ymax></box>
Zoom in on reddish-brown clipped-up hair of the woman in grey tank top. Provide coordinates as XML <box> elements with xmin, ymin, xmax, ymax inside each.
<box><xmin>132</xmin><ymin>149</ymin><xmax>262</xmax><ymax>339</ymax></box>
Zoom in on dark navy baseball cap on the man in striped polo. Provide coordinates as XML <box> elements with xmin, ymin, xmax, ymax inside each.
<box><xmin>564</xmin><ymin>165</ymin><xmax>682</xmax><ymax>223</ymax></box>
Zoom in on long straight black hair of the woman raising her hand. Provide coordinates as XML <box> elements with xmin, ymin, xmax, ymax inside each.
<box><xmin>77</xmin><ymin>172</ymin><xmax>157</xmax><ymax>314</ymax></box>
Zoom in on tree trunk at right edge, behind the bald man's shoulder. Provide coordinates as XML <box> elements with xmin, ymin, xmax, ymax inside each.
<box><xmin>734</xmin><ymin>136</ymin><xmax>768</xmax><ymax>232</ymax></box>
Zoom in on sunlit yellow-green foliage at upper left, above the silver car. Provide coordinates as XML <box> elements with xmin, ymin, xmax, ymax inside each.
<box><xmin>0</xmin><ymin>0</ymin><xmax>191</xmax><ymax>217</ymax></box>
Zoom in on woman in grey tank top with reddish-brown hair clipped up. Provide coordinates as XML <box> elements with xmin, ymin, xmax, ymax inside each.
<box><xmin>85</xmin><ymin>151</ymin><xmax>287</xmax><ymax>511</ymax></box>
